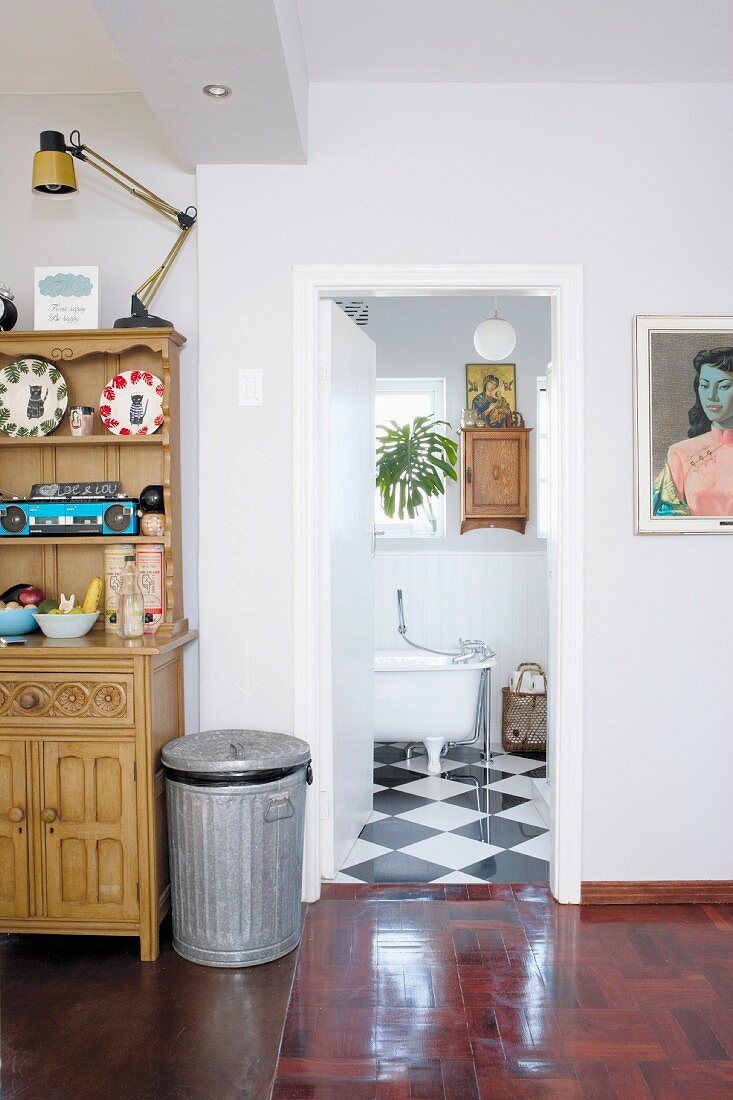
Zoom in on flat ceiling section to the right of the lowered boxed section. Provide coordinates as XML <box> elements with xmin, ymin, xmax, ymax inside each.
<box><xmin>298</xmin><ymin>0</ymin><xmax>733</xmax><ymax>84</ymax></box>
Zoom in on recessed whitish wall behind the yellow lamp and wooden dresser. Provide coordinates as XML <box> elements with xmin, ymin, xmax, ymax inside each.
<box><xmin>0</xmin><ymin>94</ymin><xmax>198</xmax><ymax>729</ymax></box>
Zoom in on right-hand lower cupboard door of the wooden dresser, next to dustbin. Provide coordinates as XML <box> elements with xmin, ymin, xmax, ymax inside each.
<box><xmin>43</xmin><ymin>741</ymin><xmax>139</xmax><ymax>921</ymax></box>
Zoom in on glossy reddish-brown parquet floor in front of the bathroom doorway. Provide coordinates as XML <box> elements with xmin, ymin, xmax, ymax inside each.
<box><xmin>270</xmin><ymin>884</ymin><xmax>733</xmax><ymax>1100</ymax></box>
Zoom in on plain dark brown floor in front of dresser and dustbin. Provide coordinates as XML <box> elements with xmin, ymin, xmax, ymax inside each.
<box><xmin>0</xmin><ymin>926</ymin><xmax>296</xmax><ymax>1100</ymax></box>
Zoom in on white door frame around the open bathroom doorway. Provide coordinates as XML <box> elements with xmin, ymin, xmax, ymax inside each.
<box><xmin>293</xmin><ymin>264</ymin><xmax>583</xmax><ymax>904</ymax></box>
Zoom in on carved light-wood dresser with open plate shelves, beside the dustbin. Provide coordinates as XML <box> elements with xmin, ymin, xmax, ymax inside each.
<box><xmin>0</xmin><ymin>329</ymin><xmax>195</xmax><ymax>960</ymax></box>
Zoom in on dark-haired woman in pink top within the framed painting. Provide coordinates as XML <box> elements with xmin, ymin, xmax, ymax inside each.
<box><xmin>653</xmin><ymin>348</ymin><xmax>733</xmax><ymax>516</ymax></box>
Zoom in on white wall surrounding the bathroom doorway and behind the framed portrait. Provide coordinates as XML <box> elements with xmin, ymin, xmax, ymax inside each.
<box><xmin>198</xmin><ymin>85</ymin><xmax>733</xmax><ymax>879</ymax></box>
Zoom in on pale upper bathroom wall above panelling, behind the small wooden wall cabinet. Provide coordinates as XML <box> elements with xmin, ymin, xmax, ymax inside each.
<box><xmin>372</xmin><ymin>297</ymin><xmax>551</xmax><ymax>553</ymax></box>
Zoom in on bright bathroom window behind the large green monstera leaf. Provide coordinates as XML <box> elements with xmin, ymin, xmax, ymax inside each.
<box><xmin>374</xmin><ymin>378</ymin><xmax>446</xmax><ymax>539</ymax></box>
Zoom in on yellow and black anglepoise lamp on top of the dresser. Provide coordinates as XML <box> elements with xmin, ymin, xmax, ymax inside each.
<box><xmin>33</xmin><ymin>130</ymin><xmax>197</xmax><ymax>329</ymax></box>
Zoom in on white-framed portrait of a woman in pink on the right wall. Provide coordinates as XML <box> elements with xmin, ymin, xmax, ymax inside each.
<box><xmin>634</xmin><ymin>317</ymin><xmax>733</xmax><ymax>535</ymax></box>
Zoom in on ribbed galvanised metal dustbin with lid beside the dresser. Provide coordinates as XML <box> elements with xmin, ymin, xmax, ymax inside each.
<box><xmin>163</xmin><ymin>729</ymin><xmax>313</xmax><ymax>966</ymax></box>
